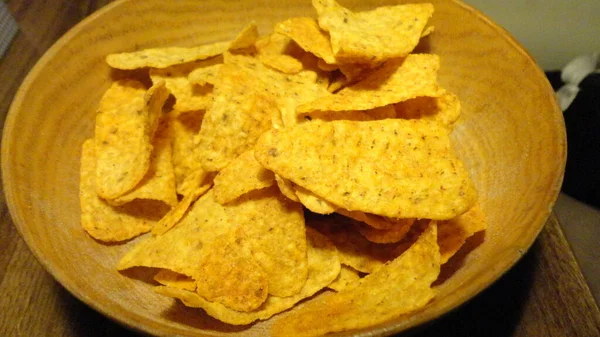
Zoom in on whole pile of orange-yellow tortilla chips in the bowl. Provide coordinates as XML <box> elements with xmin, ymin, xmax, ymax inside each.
<box><xmin>80</xmin><ymin>0</ymin><xmax>486</xmax><ymax>336</ymax></box>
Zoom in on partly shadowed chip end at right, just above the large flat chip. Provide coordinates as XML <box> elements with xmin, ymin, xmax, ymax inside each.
<box><xmin>395</xmin><ymin>92</ymin><xmax>460</xmax><ymax>127</ymax></box>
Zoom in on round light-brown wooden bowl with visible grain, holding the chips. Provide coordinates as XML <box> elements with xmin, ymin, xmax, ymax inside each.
<box><xmin>2</xmin><ymin>0</ymin><xmax>566</xmax><ymax>336</ymax></box>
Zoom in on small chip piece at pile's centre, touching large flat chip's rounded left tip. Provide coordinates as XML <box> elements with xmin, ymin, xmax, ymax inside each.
<box><xmin>214</xmin><ymin>149</ymin><xmax>275</xmax><ymax>204</ymax></box>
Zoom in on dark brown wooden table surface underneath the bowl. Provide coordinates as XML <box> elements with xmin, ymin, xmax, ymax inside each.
<box><xmin>0</xmin><ymin>0</ymin><xmax>600</xmax><ymax>337</ymax></box>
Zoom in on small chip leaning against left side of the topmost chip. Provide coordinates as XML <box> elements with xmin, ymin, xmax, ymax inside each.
<box><xmin>275</xmin><ymin>17</ymin><xmax>337</xmax><ymax>64</ymax></box>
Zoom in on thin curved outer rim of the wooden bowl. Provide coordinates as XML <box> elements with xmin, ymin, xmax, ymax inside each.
<box><xmin>0</xmin><ymin>0</ymin><xmax>567</xmax><ymax>336</ymax></box>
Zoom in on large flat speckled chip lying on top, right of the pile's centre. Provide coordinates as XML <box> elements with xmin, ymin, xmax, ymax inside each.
<box><xmin>254</xmin><ymin>119</ymin><xmax>477</xmax><ymax>220</ymax></box>
